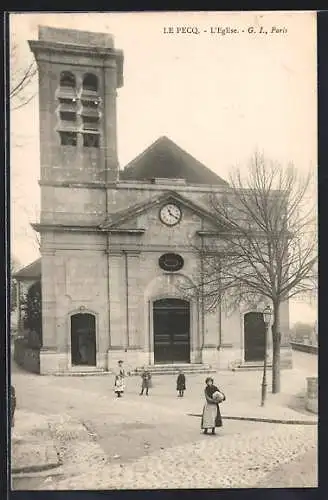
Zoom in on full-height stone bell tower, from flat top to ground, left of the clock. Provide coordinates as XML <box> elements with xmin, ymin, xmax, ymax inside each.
<box><xmin>29</xmin><ymin>27</ymin><xmax>123</xmax><ymax>373</ymax></box>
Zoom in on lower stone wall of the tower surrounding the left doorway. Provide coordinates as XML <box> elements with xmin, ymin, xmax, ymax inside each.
<box><xmin>42</xmin><ymin>247</ymin><xmax>110</xmax><ymax>370</ymax></box>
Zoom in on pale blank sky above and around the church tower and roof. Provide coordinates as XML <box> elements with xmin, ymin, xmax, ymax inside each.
<box><xmin>10</xmin><ymin>11</ymin><xmax>317</xmax><ymax>320</ymax></box>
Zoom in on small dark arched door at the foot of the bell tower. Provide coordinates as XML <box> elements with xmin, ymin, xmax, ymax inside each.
<box><xmin>71</xmin><ymin>313</ymin><xmax>96</xmax><ymax>366</ymax></box>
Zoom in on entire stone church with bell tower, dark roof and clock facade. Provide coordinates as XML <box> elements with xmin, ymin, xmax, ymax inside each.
<box><xmin>17</xmin><ymin>27</ymin><xmax>289</xmax><ymax>374</ymax></box>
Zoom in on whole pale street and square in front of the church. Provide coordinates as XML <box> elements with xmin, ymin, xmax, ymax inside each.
<box><xmin>13</xmin><ymin>350</ymin><xmax>317</xmax><ymax>489</ymax></box>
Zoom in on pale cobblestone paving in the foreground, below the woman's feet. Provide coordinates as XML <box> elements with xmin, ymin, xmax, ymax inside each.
<box><xmin>30</xmin><ymin>414</ymin><xmax>316</xmax><ymax>489</ymax></box>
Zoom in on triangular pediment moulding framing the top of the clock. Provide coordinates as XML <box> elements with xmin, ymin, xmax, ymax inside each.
<box><xmin>100</xmin><ymin>191</ymin><xmax>229</xmax><ymax>230</ymax></box>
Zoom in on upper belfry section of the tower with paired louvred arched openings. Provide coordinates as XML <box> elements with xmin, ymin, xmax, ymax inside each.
<box><xmin>29</xmin><ymin>26</ymin><xmax>123</xmax><ymax>184</ymax></box>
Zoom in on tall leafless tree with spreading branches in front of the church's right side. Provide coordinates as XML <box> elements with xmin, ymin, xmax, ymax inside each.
<box><xmin>193</xmin><ymin>153</ymin><xmax>317</xmax><ymax>393</ymax></box>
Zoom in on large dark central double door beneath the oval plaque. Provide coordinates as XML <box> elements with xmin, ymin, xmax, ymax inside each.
<box><xmin>153</xmin><ymin>299</ymin><xmax>190</xmax><ymax>363</ymax></box>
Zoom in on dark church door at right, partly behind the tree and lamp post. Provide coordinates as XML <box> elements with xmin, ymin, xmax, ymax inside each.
<box><xmin>244</xmin><ymin>312</ymin><xmax>265</xmax><ymax>361</ymax></box>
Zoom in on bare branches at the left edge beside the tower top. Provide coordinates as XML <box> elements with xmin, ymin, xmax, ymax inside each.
<box><xmin>9</xmin><ymin>41</ymin><xmax>37</xmax><ymax>111</ymax></box>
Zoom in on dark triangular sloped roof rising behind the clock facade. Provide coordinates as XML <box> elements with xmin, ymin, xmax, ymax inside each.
<box><xmin>120</xmin><ymin>136</ymin><xmax>228</xmax><ymax>186</ymax></box>
